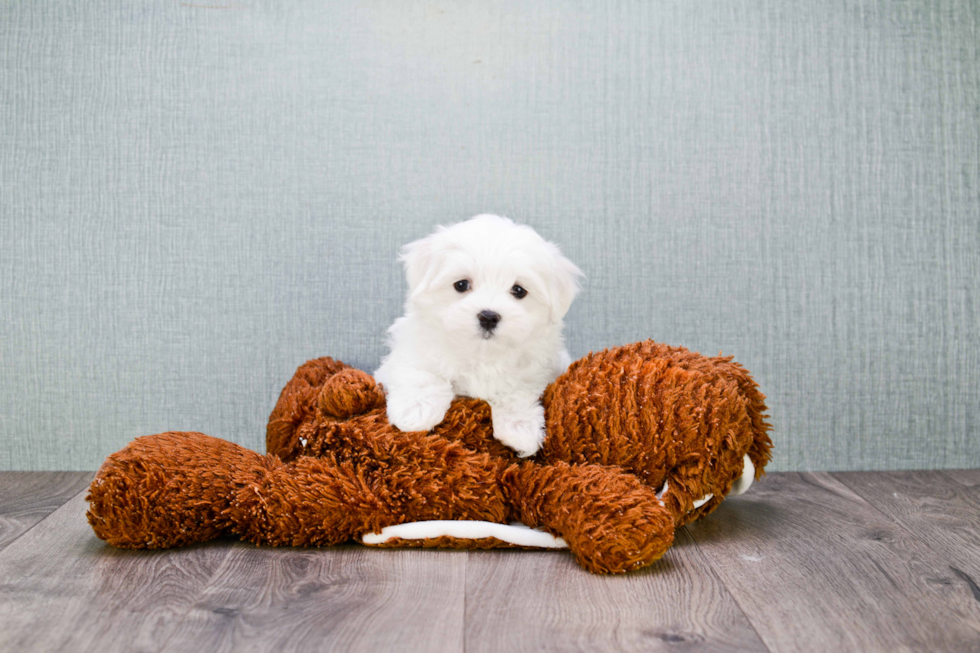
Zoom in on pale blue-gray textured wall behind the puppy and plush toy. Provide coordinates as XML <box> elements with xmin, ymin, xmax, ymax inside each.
<box><xmin>0</xmin><ymin>0</ymin><xmax>980</xmax><ymax>470</ymax></box>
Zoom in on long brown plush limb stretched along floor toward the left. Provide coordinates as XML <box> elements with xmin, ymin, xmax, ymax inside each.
<box><xmin>88</xmin><ymin>432</ymin><xmax>509</xmax><ymax>548</ymax></box>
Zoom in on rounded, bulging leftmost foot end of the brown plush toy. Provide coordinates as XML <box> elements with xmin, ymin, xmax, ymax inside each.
<box><xmin>87</xmin><ymin>432</ymin><xmax>265</xmax><ymax>549</ymax></box>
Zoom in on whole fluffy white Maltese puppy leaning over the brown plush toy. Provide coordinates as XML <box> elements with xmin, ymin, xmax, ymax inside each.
<box><xmin>374</xmin><ymin>215</ymin><xmax>582</xmax><ymax>457</ymax></box>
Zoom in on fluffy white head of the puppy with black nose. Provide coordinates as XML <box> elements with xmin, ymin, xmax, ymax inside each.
<box><xmin>401</xmin><ymin>215</ymin><xmax>582</xmax><ymax>345</ymax></box>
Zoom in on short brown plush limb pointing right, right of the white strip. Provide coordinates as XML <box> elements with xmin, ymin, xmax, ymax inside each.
<box><xmin>501</xmin><ymin>462</ymin><xmax>674</xmax><ymax>573</ymax></box>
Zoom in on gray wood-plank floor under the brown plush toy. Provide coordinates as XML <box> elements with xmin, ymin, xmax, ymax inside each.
<box><xmin>0</xmin><ymin>470</ymin><xmax>980</xmax><ymax>653</ymax></box>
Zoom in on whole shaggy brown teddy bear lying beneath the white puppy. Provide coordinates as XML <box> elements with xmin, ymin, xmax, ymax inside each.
<box><xmin>88</xmin><ymin>341</ymin><xmax>772</xmax><ymax>573</ymax></box>
